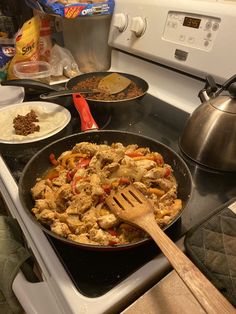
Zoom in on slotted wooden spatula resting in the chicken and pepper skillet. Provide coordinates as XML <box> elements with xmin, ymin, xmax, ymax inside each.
<box><xmin>106</xmin><ymin>185</ymin><xmax>235</xmax><ymax>314</ymax></box>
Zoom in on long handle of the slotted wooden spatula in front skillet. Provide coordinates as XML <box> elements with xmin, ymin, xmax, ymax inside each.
<box><xmin>135</xmin><ymin>214</ymin><xmax>236</xmax><ymax>314</ymax></box>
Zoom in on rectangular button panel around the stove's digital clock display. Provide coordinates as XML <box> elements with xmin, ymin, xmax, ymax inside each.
<box><xmin>163</xmin><ymin>11</ymin><xmax>221</xmax><ymax>50</ymax></box>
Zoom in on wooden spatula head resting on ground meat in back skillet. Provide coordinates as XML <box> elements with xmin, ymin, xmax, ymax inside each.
<box><xmin>98</xmin><ymin>73</ymin><xmax>131</xmax><ymax>95</ymax></box>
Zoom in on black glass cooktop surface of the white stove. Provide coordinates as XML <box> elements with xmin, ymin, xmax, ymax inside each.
<box><xmin>0</xmin><ymin>94</ymin><xmax>236</xmax><ymax>298</ymax></box>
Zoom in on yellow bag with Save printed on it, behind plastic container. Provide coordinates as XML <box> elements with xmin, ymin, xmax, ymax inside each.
<box><xmin>7</xmin><ymin>15</ymin><xmax>40</xmax><ymax>80</ymax></box>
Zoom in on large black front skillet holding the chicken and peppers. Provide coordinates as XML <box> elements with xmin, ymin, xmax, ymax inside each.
<box><xmin>19</xmin><ymin>130</ymin><xmax>192</xmax><ymax>251</ymax></box>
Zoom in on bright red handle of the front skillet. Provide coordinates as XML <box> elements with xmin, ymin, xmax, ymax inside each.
<box><xmin>73</xmin><ymin>94</ymin><xmax>99</xmax><ymax>131</ymax></box>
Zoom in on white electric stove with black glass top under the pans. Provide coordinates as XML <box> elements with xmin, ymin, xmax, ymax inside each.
<box><xmin>0</xmin><ymin>0</ymin><xmax>236</xmax><ymax>314</ymax></box>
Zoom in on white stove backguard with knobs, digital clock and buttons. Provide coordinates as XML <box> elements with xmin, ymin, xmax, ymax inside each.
<box><xmin>108</xmin><ymin>0</ymin><xmax>236</xmax><ymax>84</ymax></box>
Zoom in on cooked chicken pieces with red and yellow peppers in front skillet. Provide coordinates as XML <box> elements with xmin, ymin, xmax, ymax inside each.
<box><xmin>31</xmin><ymin>142</ymin><xmax>182</xmax><ymax>245</ymax></box>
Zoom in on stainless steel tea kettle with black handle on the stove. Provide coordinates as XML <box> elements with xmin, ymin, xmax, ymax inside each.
<box><xmin>179</xmin><ymin>75</ymin><xmax>236</xmax><ymax>171</ymax></box>
